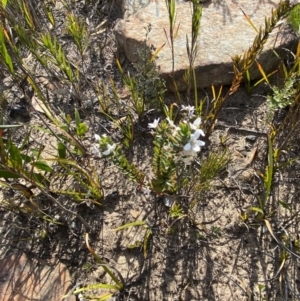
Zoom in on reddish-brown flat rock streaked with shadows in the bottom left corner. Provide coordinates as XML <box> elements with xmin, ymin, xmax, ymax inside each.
<box><xmin>0</xmin><ymin>255</ymin><xmax>75</xmax><ymax>301</ymax></box>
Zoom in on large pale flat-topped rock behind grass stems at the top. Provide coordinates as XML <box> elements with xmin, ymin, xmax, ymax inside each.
<box><xmin>115</xmin><ymin>0</ymin><xmax>297</xmax><ymax>90</ymax></box>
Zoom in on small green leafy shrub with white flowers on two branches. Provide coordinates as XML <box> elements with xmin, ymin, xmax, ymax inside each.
<box><xmin>92</xmin><ymin>106</ymin><xmax>205</xmax><ymax>194</ymax></box>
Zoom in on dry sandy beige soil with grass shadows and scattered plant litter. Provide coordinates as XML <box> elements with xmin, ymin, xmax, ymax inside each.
<box><xmin>0</xmin><ymin>1</ymin><xmax>300</xmax><ymax>301</ymax></box>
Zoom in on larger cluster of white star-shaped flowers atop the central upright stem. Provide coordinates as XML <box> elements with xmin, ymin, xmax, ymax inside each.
<box><xmin>148</xmin><ymin>106</ymin><xmax>205</xmax><ymax>165</ymax></box>
